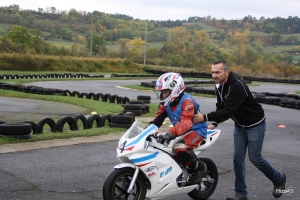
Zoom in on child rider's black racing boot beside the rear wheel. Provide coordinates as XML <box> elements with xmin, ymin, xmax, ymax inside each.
<box><xmin>189</xmin><ymin>158</ymin><xmax>207</xmax><ymax>184</ymax></box>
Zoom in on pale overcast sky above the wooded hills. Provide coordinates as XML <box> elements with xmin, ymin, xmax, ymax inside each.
<box><xmin>0</xmin><ymin>0</ymin><xmax>300</xmax><ymax>20</ymax></box>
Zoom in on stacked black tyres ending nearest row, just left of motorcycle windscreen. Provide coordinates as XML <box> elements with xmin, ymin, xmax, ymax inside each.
<box><xmin>109</xmin><ymin>112</ymin><xmax>135</xmax><ymax>128</ymax></box>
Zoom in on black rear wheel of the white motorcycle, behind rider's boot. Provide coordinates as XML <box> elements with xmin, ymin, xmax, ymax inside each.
<box><xmin>188</xmin><ymin>157</ymin><xmax>218</xmax><ymax>200</ymax></box>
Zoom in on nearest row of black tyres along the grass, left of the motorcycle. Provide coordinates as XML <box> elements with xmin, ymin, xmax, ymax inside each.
<box><xmin>0</xmin><ymin>112</ymin><xmax>135</xmax><ymax>139</ymax></box>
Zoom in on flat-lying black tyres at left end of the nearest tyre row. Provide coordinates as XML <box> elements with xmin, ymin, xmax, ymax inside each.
<box><xmin>0</xmin><ymin>123</ymin><xmax>31</xmax><ymax>139</ymax></box>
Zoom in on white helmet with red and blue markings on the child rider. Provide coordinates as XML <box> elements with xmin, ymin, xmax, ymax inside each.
<box><xmin>155</xmin><ymin>72</ymin><xmax>185</xmax><ymax>106</ymax></box>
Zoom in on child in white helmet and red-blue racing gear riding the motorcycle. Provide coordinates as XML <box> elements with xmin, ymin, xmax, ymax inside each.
<box><xmin>149</xmin><ymin>72</ymin><xmax>207</xmax><ymax>184</ymax></box>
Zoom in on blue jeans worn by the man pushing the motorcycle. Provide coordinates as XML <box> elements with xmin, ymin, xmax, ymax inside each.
<box><xmin>233</xmin><ymin>122</ymin><xmax>281</xmax><ymax>196</ymax></box>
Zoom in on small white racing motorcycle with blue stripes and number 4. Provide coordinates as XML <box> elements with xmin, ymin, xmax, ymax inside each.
<box><xmin>103</xmin><ymin>121</ymin><xmax>221</xmax><ymax>200</ymax></box>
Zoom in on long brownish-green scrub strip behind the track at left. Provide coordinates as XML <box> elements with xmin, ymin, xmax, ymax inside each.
<box><xmin>0</xmin><ymin>54</ymin><xmax>143</xmax><ymax>73</ymax></box>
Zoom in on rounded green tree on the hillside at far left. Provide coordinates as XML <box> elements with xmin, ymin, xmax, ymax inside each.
<box><xmin>7</xmin><ymin>26</ymin><xmax>33</xmax><ymax>48</ymax></box>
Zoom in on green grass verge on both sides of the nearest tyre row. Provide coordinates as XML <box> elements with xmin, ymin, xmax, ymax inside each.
<box><xmin>0</xmin><ymin>89</ymin><xmax>157</xmax><ymax>145</ymax></box>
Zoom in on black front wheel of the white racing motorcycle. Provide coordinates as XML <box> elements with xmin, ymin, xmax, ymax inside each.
<box><xmin>103</xmin><ymin>167</ymin><xmax>147</xmax><ymax>200</ymax></box>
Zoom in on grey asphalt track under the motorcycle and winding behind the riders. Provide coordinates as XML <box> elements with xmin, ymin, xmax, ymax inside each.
<box><xmin>0</xmin><ymin>80</ymin><xmax>300</xmax><ymax>200</ymax></box>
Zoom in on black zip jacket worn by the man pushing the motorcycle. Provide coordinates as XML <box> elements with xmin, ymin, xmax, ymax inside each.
<box><xmin>205</xmin><ymin>72</ymin><xmax>266</xmax><ymax>128</ymax></box>
